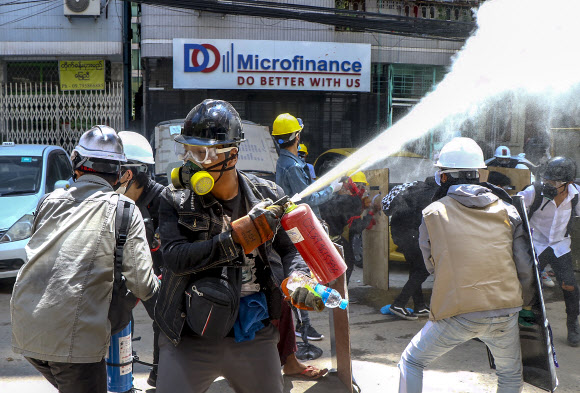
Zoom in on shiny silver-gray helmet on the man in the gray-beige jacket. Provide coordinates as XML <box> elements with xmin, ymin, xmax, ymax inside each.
<box><xmin>71</xmin><ymin>125</ymin><xmax>127</xmax><ymax>173</ymax></box>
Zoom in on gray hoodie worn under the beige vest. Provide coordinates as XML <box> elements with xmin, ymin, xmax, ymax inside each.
<box><xmin>419</xmin><ymin>184</ymin><xmax>535</xmax><ymax>318</ymax></box>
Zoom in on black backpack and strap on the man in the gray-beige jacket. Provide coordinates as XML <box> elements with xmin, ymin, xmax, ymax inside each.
<box><xmin>109</xmin><ymin>197</ymin><xmax>138</xmax><ymax>335</ymax></box>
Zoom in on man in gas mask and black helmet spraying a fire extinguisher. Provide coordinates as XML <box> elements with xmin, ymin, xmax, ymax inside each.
<box><xmin>155</xmin><ymin>99</ymin><xmax>315</xmax><ymax>393</ymax></box>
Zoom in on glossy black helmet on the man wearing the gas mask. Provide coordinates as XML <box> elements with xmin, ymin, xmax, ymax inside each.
<box><xmin>175</xmin><ymin>99</ymin><xmax>244</xmax><ymax>146</ymax></box>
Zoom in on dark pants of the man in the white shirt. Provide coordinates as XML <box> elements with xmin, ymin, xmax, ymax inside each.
<box><xmin>538</xmin><ymin>247</ymin><xmax>580</xmax><ymax>318</ymax></box>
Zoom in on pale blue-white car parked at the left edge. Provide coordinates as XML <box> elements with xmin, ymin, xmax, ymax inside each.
<box><xmin>0</xmin><ymin>142</ymin><xmax>72</xmax><ymax>279</ymax></box>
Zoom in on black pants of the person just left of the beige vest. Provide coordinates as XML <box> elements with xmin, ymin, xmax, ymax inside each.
<box><xmin>393</xmin><ymin>245</ymin><xmax>429</xmax><ymax>309</ymax></box>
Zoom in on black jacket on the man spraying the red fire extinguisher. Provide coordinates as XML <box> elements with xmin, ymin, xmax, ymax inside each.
<box><xmin>155</xmin><ymin>171</ymin><xmax>308</xmax><ymax>345</ymax></box>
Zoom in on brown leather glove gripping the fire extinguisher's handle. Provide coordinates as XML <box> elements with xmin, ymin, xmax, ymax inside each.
<box><xmin>232</xmin><ymin>199</ymin><xmax>283</xmax><ymax>254</ymax></box>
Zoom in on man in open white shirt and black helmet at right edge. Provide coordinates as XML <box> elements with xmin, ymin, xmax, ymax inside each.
<box><xmin>518</xmin><ymin>157</ymin><xmax>580</xmax><ymax>347</ymax></box>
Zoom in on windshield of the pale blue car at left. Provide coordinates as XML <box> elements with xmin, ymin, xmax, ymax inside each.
<box><xmin>0</xmin><ymin>156</ymin><xmax>42</xmax><ymax>196</ymax></box>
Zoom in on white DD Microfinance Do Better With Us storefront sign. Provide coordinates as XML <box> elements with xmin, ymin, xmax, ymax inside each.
<box><xmin>173</xmin><ymin>38</ymin><xmax>371</xmax><ymax>92</ymax></box>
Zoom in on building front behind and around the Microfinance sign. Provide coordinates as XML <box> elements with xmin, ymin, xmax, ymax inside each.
<box><xmin>140</xmin><ymin>0</ymin><xmax>479</xmax><ymax>157</ymax></box>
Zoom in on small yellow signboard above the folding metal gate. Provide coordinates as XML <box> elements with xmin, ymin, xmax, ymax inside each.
<box><xmin>58</xmin><ymin>60</ymin><xmax>105</xmax><ymax>90</ymax></box>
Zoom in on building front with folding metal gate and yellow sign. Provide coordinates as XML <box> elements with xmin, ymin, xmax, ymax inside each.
<box><xmin>0</xmin><ymin>0</ymin><xmax>127</xmax><ymax>151</ymax></box>
